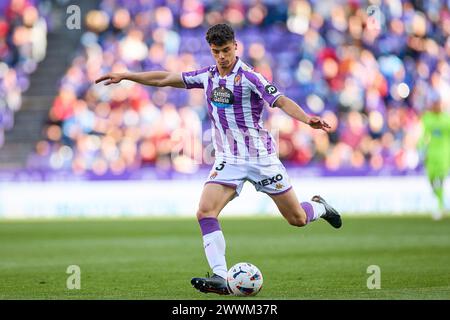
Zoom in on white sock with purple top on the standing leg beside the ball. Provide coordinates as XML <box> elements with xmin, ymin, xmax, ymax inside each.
<box><xmin>198</xmin><ymin>217</ymin><xmax>228</xmax><ymax>279</ymax></box>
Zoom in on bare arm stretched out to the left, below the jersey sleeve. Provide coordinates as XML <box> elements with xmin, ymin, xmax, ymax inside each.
<box><xmin>95</xmin><ymin>71</ymin><xmax>185</xmax><ymax>88</ymax></box>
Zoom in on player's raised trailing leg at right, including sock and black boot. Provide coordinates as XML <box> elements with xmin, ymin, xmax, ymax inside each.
<box><xmin>268</xmin><ymin>188</ymin><xmax>342</xmax><ymax>228</ymax></box>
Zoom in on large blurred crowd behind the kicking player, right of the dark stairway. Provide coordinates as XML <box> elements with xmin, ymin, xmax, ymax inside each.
<box><xmin>29</xmin><ymin>0</ymin><xmax>450</xmax><ymax>176</ymax></box>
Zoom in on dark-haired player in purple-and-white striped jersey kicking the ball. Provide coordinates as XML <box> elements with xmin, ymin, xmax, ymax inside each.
<box><xmin>96</xmin><ymin>24</ymin><xmax>342</xmax><ymax>294</ymax></box>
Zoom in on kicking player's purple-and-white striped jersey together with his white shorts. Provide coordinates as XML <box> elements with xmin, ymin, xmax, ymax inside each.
<box><xmin>182</xmin><ymin>57</ymin><xmax>291</xmax><ymax>195</ymax></box>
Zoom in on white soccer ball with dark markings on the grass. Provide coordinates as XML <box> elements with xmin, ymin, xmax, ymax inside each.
<box><xmin>227</xmin><ymin>262</ymin><xmax>263</xmax><ymax>296</ymax></box>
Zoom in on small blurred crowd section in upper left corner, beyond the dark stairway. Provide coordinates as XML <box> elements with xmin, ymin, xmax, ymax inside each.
<box><xmin>0</xmin><ymin>0</ymin><xmax>48</xmax><ymax>148</ymax></box>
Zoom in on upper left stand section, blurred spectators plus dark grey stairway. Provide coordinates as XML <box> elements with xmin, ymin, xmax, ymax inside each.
<box><xmin>0</xmin><ymin>0</ymin><xmax>96</xmax><ymax>169</ymax></box>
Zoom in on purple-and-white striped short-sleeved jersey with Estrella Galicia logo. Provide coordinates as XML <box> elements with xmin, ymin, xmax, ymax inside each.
<box><xmin>182</xmin><ymin>58</ymin><xmax>283</xmax><ymax>159</ymax></box>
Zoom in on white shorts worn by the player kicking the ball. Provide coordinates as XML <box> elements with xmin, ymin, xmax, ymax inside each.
<box><xmin>205</xmin><ymin>156</ymin><xmax>292</xmax><ymax>196</ymax></box>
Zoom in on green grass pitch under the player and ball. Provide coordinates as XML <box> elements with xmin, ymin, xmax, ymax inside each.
<box><xmin>0</xmin><ymin>217</ymin><xmax>450</xmax><ymax>299</ymax></box>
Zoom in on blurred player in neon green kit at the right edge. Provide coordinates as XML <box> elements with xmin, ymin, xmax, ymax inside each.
<box><xmin>419</xmin><ymin>99</ymin><xmax>450</xmax><ymax>220</ymax></box>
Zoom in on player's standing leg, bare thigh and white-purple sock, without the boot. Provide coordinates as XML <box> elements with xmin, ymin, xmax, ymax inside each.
<box><xmin>197</xmin><ymin>183</ymin><xmax>236</xmax><ymax>279</ymax></box>
